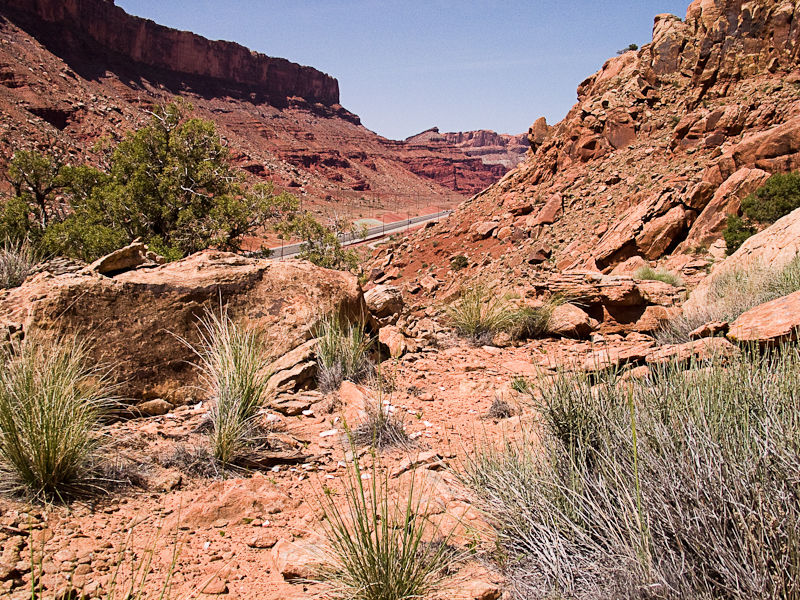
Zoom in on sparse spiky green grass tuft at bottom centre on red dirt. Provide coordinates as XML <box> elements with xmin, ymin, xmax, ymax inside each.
<box><xmin>320</xmin><ymin>448</ymin><xmax>454</xmax><ymax>600</ymax></box>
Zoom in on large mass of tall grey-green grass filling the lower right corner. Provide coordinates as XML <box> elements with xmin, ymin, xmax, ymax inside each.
<box><xmin>462</xmin><ymin>348</ymin><xmax>800</xmax><ymax>600</ymax></box>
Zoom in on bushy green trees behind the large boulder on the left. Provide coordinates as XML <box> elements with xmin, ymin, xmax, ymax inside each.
<box><xmin>0</xmin><ymin>101</ymin><xmax>298</xmax><ymax>261</ymax></box>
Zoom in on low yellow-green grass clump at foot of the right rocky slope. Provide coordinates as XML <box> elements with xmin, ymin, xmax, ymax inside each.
<box><xmin>446</xmin><ymin>285</ymin><xmax>563</xmax><ymax>344</ymax></box>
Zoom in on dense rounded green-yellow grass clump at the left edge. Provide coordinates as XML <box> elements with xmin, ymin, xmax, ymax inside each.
<box><xmin>0</xmin><ymin>334</ymin><xmax>109</xmax><ymax>499</ymax></box>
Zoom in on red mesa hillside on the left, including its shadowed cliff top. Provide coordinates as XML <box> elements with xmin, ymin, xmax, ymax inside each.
<box><xmin>0</xmin><ymin>0</ymin><xmax>520</xmax><ymax>217</ymax></box>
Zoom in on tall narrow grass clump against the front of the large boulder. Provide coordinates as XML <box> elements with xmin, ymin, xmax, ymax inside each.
<box><xmin>190</xmin><ymin>310</ymin><xmax>272</xmax><ymax>468</ymax></box>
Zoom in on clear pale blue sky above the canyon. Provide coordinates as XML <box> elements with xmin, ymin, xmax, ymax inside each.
<box><xmin>116</xmin><ymin>0</ymin><xmax>689</xmax><ymax>139</ymax></box>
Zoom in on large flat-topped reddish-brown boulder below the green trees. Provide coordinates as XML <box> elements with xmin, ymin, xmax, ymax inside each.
<box><xmin>0</xmin><ymin>251</ymin><xmax>369</xmax><ymax>403</ymax></box>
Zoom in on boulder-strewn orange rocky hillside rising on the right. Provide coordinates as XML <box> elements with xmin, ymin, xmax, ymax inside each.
<box><xmin>377</xmin><ymin>0</ymin><xmax>800</xmax><ymax>310</ymax></box>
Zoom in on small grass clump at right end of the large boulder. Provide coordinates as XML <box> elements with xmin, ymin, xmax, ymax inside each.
<box><xmin>316</xmin><ymin>315</ymin><xmax>373</xmax><ymax>393</ymax></box>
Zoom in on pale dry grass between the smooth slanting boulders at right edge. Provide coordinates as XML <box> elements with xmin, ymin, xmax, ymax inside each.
<box><xmin>656</xmin><ymin>255</ymin><xmax>800</xmax><ymax>343</ymax></box>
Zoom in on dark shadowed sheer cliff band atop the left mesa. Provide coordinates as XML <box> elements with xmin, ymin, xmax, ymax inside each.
<box><xmin>0</xmin><ymin>0</ymin><xmax>339</xmax><ymax>106</ymax></box>
